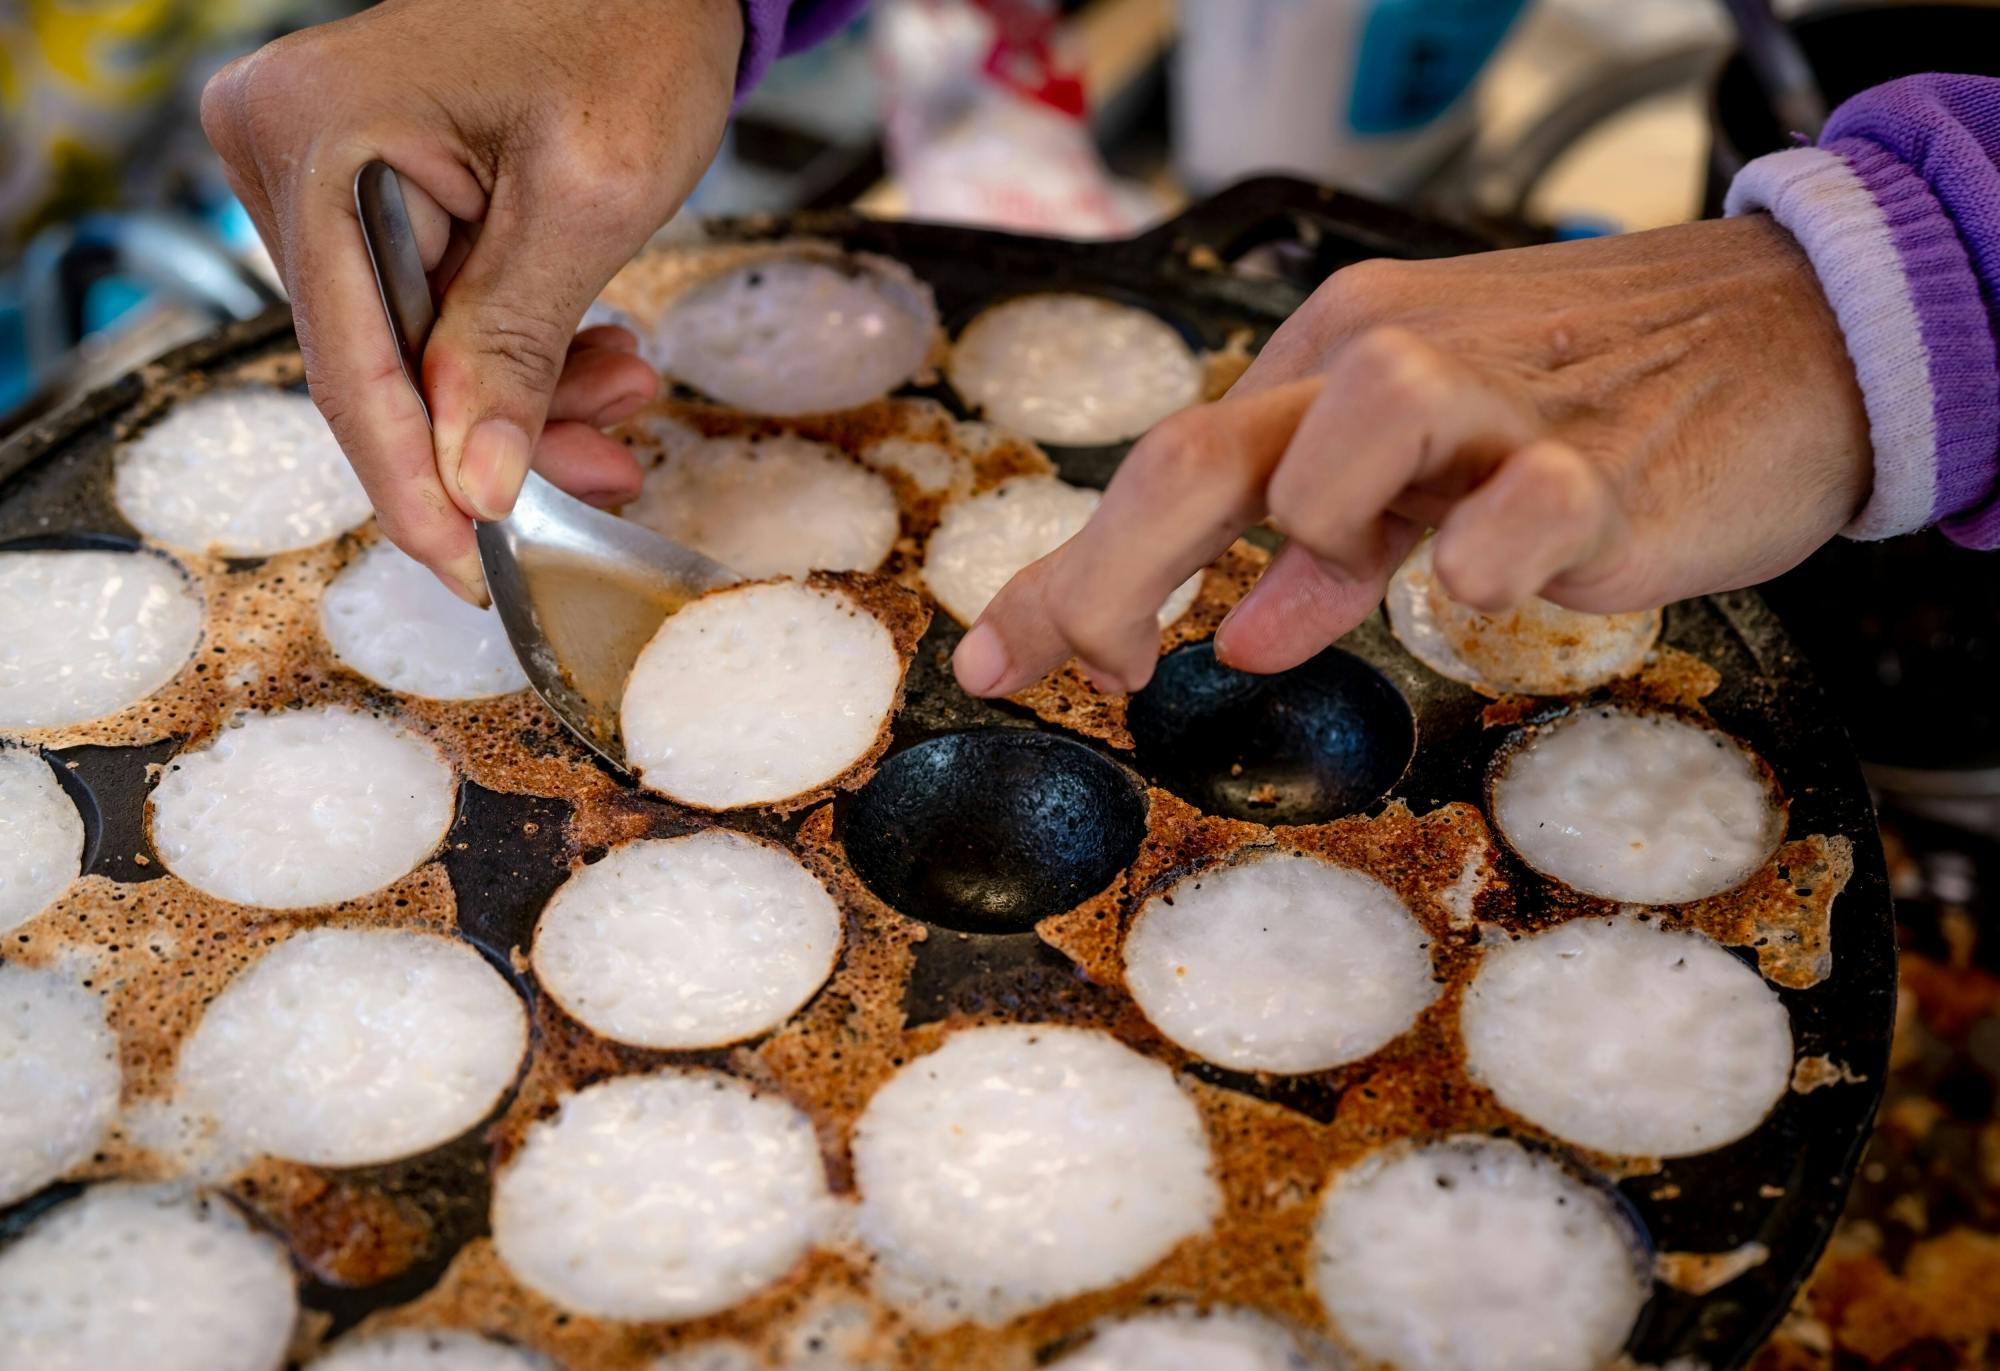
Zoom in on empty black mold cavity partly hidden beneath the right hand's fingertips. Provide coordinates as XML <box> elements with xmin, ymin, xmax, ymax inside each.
<box><xmin>1126</xmin><ymin>644</ymin><xmax>1416</xmax><ymax>823</ymax></box>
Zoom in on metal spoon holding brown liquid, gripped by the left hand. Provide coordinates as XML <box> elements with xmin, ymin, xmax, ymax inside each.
<box><xmin>354</xmin><ymin>162</ymin><xmax>742</xmax><ymax>771</ymax></box>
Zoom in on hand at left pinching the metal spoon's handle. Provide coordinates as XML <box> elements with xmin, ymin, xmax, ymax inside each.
<box><xmin>202</xmin><ymin>0</ymin><xmax>742</xmax><ymax>604</ymax></box>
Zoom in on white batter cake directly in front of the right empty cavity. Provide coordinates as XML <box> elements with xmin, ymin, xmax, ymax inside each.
<box><xmin>1124</xmin><ymin>853</ymin><xmax>1438</xmax><ymax>1073</ymax></box>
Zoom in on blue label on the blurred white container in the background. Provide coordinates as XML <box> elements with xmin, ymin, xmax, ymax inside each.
<box><xmin>1348</xmin><ymin>0</ymin><xmax>1528</xmax><ymax>134</ymax></box>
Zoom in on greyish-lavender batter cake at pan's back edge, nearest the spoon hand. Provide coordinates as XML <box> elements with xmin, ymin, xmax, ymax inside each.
<box><xmin>650</xmin><ymin>256</ymin><xmax>938</xmax><ymax>414</ymax></box>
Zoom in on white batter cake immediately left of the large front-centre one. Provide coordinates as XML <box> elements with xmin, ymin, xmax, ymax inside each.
<box><xmin>492</xmin><ymin>1071</ymin><xmax>830</xmax><ymax>1319</ymax></box>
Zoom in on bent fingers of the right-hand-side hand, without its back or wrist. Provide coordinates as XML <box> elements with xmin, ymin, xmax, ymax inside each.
<box><xmin>954</xmin><ymin>317</ymin><xmax>1618</xmax><ymax>695</ymax></box>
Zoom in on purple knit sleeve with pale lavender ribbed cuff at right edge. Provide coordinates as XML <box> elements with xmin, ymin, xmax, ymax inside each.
<box><xmin>1728</xmin><ymin>76</ymin><xmax>2000</xmax><ymax>548</ymax></box>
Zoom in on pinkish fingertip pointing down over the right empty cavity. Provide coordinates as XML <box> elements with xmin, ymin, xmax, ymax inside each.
<box><xmin>1216</xmin><ymin>514</ymin><xmax>1422</xmax><ymax>672</ymax></box>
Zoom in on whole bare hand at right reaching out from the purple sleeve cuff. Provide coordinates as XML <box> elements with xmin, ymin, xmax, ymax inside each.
<box><xmin>954</xmin><ymin>216</ymin><xmax>1872</xmax><ymax>695</ymax></box>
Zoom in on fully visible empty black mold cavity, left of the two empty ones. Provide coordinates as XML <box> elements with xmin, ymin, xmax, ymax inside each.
<box><xmin>842</xmin><ymin>727</ymin><xmax>1146</xmax><ymax>933</ymax></box>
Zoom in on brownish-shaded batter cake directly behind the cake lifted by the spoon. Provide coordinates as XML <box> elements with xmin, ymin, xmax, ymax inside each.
<box><xmin>624</xmin><ymin>434</ymin><xmax>902</xmax><ymax>580</ymax></box>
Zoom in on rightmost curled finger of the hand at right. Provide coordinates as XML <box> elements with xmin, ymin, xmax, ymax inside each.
<box><xmin>1432</xmin><ymin>440</ymin><xmax>1622</xmax><ymax>614</ymax></box>
